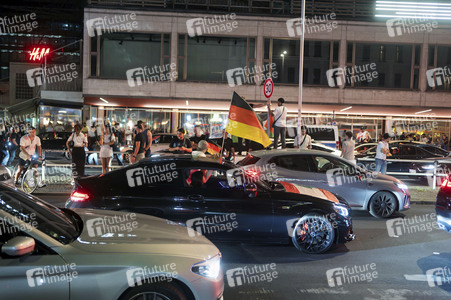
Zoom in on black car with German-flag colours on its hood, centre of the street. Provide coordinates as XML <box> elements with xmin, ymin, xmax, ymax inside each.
<box><xmin>66</xmin><ymin>156</ymin><xmax>354</xmax><ymax>253</ymax></box>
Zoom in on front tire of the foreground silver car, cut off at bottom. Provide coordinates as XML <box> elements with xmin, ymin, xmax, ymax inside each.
<box><xmin>119</xmin><ymin>282</ymin><xmax>188</xmax><ymax>300</ymax></box>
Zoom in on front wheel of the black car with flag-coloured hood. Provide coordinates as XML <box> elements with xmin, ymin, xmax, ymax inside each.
<box><xmin>292</xmin><ymin>214</ymin><xmax>335</xmax><ymax>254</ymax></box>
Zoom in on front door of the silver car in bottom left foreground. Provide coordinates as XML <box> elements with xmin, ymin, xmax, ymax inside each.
<box><xmin>0</xmin><ymin>221</ymin><xmax>69</xmax><ymax>300</ymax></box>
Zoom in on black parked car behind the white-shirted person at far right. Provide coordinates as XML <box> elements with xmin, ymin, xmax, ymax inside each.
<box><xmin>356</xmin><ymin>141</ymin><xmax>451</xmax><ymax>180</ymax></box>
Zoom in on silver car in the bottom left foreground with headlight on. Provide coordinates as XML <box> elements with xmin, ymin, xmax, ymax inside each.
<box><xmin>0</xmin><ymin>184</ymin><xmax>224</xmax><ymax>300</ymax></box>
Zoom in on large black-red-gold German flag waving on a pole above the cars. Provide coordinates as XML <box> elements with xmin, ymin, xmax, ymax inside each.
<box><xmin>226</xmin><ymin>92</ymin><xmax>271</xmax><ymax>148</ymax></box>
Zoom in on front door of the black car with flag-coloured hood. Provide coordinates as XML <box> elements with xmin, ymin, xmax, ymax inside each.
<box><xmin>185</xmin><ymin>168</ymin><xmax>273</xmax><ymax>240</ymax></box>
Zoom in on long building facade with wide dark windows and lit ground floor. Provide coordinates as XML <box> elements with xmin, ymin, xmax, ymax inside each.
<box><xmin>83</xmin><ymin>1</ymin><xmax>451</xmax><ymax>139</ymax></box>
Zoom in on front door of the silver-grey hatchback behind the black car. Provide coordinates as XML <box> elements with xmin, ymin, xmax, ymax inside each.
<box><xmin>310</xmin><ymin>155</ymin><xmax>371</xmax><ymax>206</ymax></box>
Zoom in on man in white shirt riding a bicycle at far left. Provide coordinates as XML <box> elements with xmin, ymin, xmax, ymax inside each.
<box><xmin>14</xmin><ymin>127</ymin><xmax>42</xmax><ymax>186</ymax></box>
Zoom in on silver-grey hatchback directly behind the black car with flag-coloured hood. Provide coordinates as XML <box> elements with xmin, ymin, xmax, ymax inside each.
<box><xmin>238</xmin><ymin>149</ymin><xmax>410</xmax><ymax>218</ymax></box>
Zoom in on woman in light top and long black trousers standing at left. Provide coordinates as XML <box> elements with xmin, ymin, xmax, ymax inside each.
<box><xmin>66</xmin><ymin>124</ymin><xmax>88</xmax><ymax>178</ymax></box>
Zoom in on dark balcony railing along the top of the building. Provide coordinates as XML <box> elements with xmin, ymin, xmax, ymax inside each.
<box><xmin>88</xmin><ymin>0</ymin><xmax>375</xmax><ymax>20</ymax></box>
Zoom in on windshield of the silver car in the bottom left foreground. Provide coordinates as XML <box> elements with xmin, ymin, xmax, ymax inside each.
<box><xmin>0</xmin><ymin>189</ymin><xmax>81</xmax><ymax>244</ymax></box>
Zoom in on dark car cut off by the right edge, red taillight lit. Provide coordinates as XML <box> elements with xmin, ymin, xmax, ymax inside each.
<box><xmin>435</xmin><ymin>175</ymin><xmax>451</xmax><ymax>232</ymax></box>
